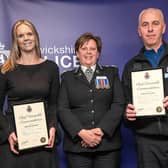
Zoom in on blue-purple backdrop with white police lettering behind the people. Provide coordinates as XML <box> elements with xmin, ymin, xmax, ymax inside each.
<box><xmin>0</xmin><ymin>0</ymin><xmax>168</xmax><ymax>168</ymax></box>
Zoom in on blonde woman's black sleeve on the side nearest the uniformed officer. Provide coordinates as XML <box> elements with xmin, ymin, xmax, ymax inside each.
<box><xmin>47</xmin><ymin>63</ymin><xmax>60</xmax><ymax>128</ymax></box>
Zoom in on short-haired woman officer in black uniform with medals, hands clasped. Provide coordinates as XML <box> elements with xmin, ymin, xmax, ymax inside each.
<box><xmin>58</xmin><ymin>33</ymin><xmax>124</xmax><ymax>168</ymax></box>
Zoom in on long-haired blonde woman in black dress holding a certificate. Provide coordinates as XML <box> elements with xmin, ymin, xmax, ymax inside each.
<box><xmin>0</xmin><ymin>20</ymin><xmax>59</xmax><ymax>168</ymax></box>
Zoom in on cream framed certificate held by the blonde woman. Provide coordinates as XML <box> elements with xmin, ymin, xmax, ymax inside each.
<box><xmin>13</xmin><ymin>102</ymin><xmax>48</xmax><ymax>150</ymax></box>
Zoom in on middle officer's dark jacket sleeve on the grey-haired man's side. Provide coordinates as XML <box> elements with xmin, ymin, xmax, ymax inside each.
<box><xmin>98</xmin><ymin>68</ymin><xmax>125</xmax><ymax>137</ymax></box>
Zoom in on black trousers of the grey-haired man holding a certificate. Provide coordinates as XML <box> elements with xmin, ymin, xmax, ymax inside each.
<box><xmin>136</xmin><ymin>135</ymin><xmax>168</xmax><ymax>168</ymax></box>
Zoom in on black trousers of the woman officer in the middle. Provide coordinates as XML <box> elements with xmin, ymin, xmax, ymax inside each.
<box><xmin>66</xmin><ymin>150</ymin><xmax>121</xmax><ymax>168</ymax></box>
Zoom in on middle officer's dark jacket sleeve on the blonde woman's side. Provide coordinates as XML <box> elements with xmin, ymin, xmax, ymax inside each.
<box><xmin>58</xmin><ymin>74</ymin><xmax>83</xmax><ymax>140</ymax></box>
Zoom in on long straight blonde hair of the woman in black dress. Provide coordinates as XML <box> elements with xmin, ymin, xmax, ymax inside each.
<box><xmin>1</xmin><ymin>20</ymin><xmax>41</xmax><ymax>74</ymax></box>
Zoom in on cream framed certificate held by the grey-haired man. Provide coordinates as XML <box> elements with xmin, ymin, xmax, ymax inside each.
<box><xmin>131</xmin><ymin>68</ymin><xmax>165</xmax><ymax>116</ymax></box>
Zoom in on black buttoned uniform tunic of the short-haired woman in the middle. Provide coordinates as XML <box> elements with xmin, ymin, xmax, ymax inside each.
<box><xmin>58</xmin><ymin>65</ymin><xmax>124</xmax><ymax>153</ymax></box>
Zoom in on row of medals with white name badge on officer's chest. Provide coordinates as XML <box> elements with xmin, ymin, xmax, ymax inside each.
<box><xmin>95</xmin><ymin>76</ymin><xmax>110</xmax><ymax>89</ymax></box>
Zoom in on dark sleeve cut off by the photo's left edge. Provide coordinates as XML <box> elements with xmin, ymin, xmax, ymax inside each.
<box><xmin>0</xmin><ymin>73</ymin><xmax>9</xmax><ymax>143</ymax></box>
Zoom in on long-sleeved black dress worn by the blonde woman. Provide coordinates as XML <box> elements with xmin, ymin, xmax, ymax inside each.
<box><xmin>0</xmin><ymin>60</ymin><xmax>59</xmax><ymax>168</ymax></box>
